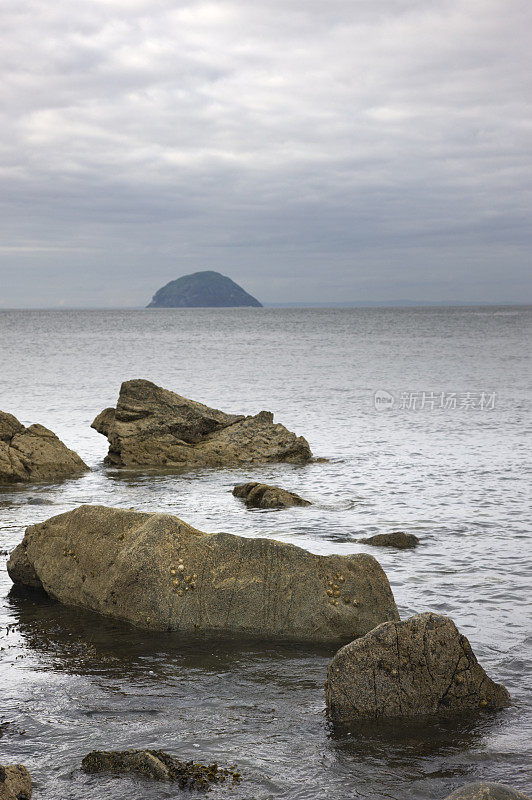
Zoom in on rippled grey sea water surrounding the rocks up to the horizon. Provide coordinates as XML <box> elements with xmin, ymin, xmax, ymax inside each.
<box><xmin>0</xmin><ymin>307</ymin><xmax>532</xmax><ymax>800</ymax></box>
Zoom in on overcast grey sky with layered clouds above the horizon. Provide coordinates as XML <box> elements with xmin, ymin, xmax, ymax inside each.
<box><xmin>0</xmin><ymin>0</ymin><xmax>532</xmax><ymax>307</ymax></box>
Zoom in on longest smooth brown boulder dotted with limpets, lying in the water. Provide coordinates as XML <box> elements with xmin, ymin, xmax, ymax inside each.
<box><xmin>8</xmin><ymin>506</ymin><xmax>398</xmax><ymax>643</ymax></box>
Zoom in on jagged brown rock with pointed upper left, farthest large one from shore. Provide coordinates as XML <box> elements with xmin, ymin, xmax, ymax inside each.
<box><xmin>92</xmin><ymin>379</ymin><xmax>312</xmax><ymax>467</ymax></box>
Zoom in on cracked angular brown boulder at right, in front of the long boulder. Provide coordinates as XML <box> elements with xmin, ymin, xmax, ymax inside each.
<box><xmin>326</xmin><ymin>613</ymin><xmax>510</xmax><ymax>722</ymax></box>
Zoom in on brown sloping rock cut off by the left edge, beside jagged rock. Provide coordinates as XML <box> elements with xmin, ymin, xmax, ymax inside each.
<box><xmin>0</xmin><ymin>411</ymin><xmax>88</xmax><ymax>483</ymax></box>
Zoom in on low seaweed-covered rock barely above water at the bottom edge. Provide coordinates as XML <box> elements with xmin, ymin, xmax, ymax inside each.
<box><xmin>81</xmin><ymin>750</ymin><xmax>241</xmax><ymax>791</ymax></box>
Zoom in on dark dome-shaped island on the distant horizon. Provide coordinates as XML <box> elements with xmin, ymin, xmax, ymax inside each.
<box><xmin>147</xmin><ymin>270</ymin><xmax>262</xmax><ymax>308</ymax></box>
